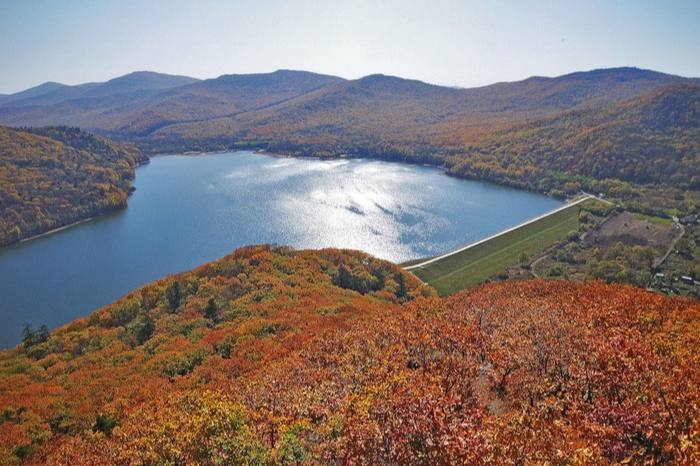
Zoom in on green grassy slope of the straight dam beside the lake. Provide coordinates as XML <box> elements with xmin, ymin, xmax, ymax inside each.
<box><xmin>411</xmin><ymin>205</ymin><xmax>581</xmax><ymax>296</ymax></box>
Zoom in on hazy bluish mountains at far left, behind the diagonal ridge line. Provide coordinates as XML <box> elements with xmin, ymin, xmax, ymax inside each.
<box><xmin>0</xmin><ymin>70</ymin><xmax>341</xmax><ymax>135</ymax></box>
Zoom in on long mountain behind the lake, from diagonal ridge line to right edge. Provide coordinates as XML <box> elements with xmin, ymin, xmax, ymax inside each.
<box><xmin>140</xmin><ymin>68</ymin><xmax>691</xmax><ymax>151</ymax></box>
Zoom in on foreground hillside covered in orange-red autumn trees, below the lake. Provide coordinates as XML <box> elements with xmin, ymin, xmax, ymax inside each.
<box><xmin>0</xmin><ymin>246</ymin><xmax>700</xmax><ymax>464</ymax></box>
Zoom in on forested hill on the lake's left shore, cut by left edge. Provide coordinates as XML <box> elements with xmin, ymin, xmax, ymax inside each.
<box><xmin>0</xmin><ymin>127</ymin><xmax>146</xmax><ymax>245</ymax></box>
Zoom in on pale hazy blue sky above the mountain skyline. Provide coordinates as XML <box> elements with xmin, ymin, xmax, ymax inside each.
<box><xmin>0</xmin><ymin>0</ymin><xmax>700</xmax><ymax>93</ymax></box>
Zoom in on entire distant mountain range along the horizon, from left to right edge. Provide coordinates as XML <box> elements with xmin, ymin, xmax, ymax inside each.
<box><xmin>0</xmin><ymin>68</ymin><xmax>690</xmax><ymax>140</ymax></box>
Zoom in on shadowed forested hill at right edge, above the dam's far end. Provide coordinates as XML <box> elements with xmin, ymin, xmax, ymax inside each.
<box><xmin>448</xmin><ymin>85</ymin><xmax>700</xmax><ymax>210</ymax></box>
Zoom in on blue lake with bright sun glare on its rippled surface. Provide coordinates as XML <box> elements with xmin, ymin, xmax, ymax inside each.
<box><xmin>0</xmin><ymin>151</ymin><xmax>561</xmax><ymax>347</ymax></box>
